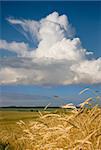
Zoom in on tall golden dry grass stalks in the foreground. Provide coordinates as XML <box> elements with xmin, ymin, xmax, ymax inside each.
<box><xmin>0</xmin><ymin>106</ymin><xmax>101</xmax><ymax>150</ymax></box>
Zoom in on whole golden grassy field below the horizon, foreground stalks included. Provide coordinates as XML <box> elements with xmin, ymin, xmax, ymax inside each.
<box><xmin>0</xmin><ymin>106</ymin><xmax>101</xmax><ymax>150</ymax></box>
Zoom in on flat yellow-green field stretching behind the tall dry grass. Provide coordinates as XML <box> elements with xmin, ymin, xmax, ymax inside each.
<box><xmin>0</xmin><ymin>108</ymin><xmax>62</xmax><ymax>131</ymax></box>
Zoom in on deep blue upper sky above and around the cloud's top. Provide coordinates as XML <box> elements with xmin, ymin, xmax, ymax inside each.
<box><xmin>0</xmin><ymin>1</ymin><xmax>101</xmax><ymax>57</ymax></box>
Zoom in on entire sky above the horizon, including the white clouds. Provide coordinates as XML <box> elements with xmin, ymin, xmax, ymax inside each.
<box><xmin>0</xmin><ymin>1</ymin><xmax>101</xmax><ymax>106</ymax></box>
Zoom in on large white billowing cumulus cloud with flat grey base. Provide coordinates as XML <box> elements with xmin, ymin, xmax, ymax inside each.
<box><xmin>0</xmin><ymin>12</ymin><xmax>101</xmax><ymax>85</ymax></box>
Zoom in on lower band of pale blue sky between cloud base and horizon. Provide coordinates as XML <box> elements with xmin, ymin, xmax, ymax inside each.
<box><xmin>1</xmin><ymin>84</ymin><xmax>101</xmax><ymax>106</ymax></box>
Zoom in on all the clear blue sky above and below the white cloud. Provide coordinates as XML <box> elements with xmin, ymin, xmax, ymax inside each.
<box><xmin>0</xmin><ymin>1</ymin><xmax>101</xmax><ymax>106</ymax></box>
